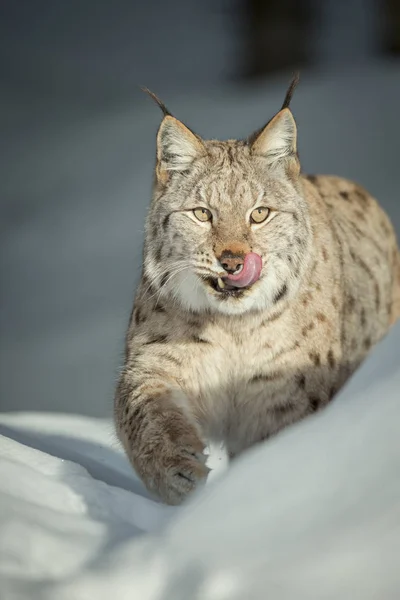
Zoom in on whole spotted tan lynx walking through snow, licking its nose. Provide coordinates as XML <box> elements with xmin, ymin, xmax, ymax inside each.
<box><xmin>115</xmin><ymin>78</ymin><xmax>400</xmax><ymax>504</ymax></box>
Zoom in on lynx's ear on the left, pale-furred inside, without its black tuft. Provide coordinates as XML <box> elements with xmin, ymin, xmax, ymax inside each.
<box><xmin>156</xmin><ymin>115</ymin><xmax>205</xmax><ymax>183</ymax></box>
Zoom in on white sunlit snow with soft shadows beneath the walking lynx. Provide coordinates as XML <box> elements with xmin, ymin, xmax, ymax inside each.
<box><xmin>0</xmin><ymin>324</ymin><xmax>400</xmax><ymax>600</ymax></box>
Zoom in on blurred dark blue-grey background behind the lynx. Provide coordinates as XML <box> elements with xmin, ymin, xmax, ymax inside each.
<box><xmin>0</xmin><ymin>0</ymin><xmax>400</xmax><ymax>416</ymax></box>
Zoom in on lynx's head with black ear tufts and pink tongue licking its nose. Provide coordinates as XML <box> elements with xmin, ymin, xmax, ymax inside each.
<box><xmin>144</xmin><ymin>78</ymin><xmax>311</xmax><ymax>314</ymax></box>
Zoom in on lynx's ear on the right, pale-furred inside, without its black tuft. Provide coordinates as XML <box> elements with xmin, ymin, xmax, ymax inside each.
<box><xmin>251</xmin><ymin>108</ymin><xmax>298</xmax><ymax>167</ymax></box>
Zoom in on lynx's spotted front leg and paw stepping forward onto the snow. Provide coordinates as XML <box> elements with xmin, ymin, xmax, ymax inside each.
<box><xmin>115</xmin><ymin>371</ymin><xmax>209</xmax><ymax>504</ymax></box>
